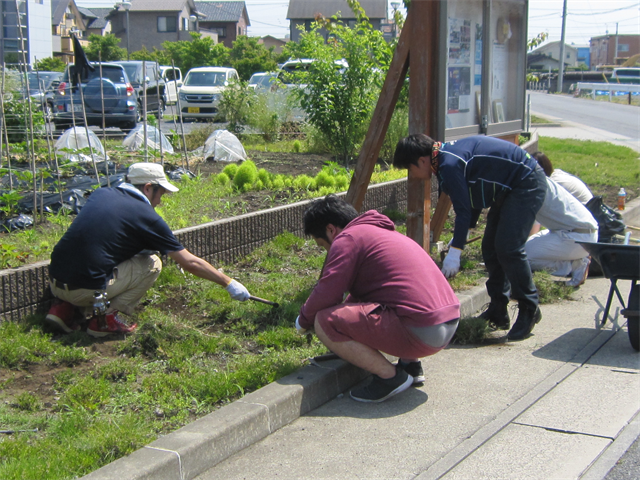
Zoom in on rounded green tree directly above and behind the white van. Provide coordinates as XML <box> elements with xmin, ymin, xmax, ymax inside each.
<box><xmin>162</xmin><ymin>32</ymin><xmax>230</xmax><ymax>71</ymax></box>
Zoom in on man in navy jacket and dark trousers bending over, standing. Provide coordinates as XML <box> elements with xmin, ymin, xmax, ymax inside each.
<box><xmin>393</xmin><ymin>134</ymin><xmax>546</xmax><ymax>340</ymax></box>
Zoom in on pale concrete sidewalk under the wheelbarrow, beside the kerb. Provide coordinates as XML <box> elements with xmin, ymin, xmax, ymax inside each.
<box><xmin>197</xmin><ymin>278</ymin><xmax>640</xmax><ymax>480</ymax></box>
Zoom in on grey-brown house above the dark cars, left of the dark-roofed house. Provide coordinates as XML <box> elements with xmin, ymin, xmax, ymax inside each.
<box><xmin>106</xmin><ymin>0</ymin><xmax>215</xmax><ymax>52</ymax></box>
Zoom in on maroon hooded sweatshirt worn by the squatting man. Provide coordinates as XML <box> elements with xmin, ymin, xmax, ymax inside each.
<box><xmin>299</xmin><ymin>210</ymin><xmax>460</xmax><ymax>329</ymax></box>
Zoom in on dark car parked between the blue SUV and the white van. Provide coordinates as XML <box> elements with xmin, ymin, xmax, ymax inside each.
<box><xmin>113</xmin><ymin>60</ymin><xmax>165</xmax><ymax>121</ymax></box>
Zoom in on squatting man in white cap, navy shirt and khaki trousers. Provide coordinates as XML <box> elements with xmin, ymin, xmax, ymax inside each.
<box><xmin>46</xmin><ymin>163</ymin><xmax>249</xmax><ymax>337</ymax></box>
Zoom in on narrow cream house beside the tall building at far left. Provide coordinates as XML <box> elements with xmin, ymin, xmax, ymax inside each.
<box><xmin>50</xmin><ymin>0</ymin><xmax>89</xmax><ymax>63</ymax></box>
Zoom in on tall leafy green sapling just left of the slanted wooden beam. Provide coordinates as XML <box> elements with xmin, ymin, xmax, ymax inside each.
<box><xmin>288</xmin><ymin>0</ymin><xmax>392</xmax><ymax>163</ymax></box>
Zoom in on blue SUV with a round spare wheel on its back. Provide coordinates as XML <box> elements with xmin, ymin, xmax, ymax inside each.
<box><xmin>53</xmin><ymin>63</ymin><xmax>138</xmax><ymax>131</ymax></box>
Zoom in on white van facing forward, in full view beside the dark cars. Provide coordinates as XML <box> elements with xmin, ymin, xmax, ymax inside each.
<box><xmin>178</xmin><ymin>67</ymin><xmax>238</xmax><ymax>118</ymax></box>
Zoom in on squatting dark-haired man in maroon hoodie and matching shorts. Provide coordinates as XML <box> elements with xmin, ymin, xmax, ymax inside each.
<box><xmin>296</xmin><ymin>195</ymin><xmax>460</xmax><ymax>402</ymax></box>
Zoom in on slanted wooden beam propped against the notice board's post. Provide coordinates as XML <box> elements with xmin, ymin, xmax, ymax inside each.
<box><xmin>347</xmin><ymin>16</ymin><xmax>411</xmax><ymax>211</ymax></box>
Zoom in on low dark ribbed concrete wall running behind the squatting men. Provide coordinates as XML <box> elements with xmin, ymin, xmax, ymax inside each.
<box><xmin>0</xmin><ymin>179</ymin><xmax>410</xmax><ymax>320</ymax></box>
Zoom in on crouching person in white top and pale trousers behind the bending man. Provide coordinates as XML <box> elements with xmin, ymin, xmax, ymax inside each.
<box><xmin>525</xmin><ymin>177</ymin><xmax>598</xmax><ymax>287</ymax></box>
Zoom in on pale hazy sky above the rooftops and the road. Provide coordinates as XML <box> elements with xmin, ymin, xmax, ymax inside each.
<box><xmin>76</xmin><ymin>0</ymin><xmax>640</xmax><ymax>44</ymax></box>
